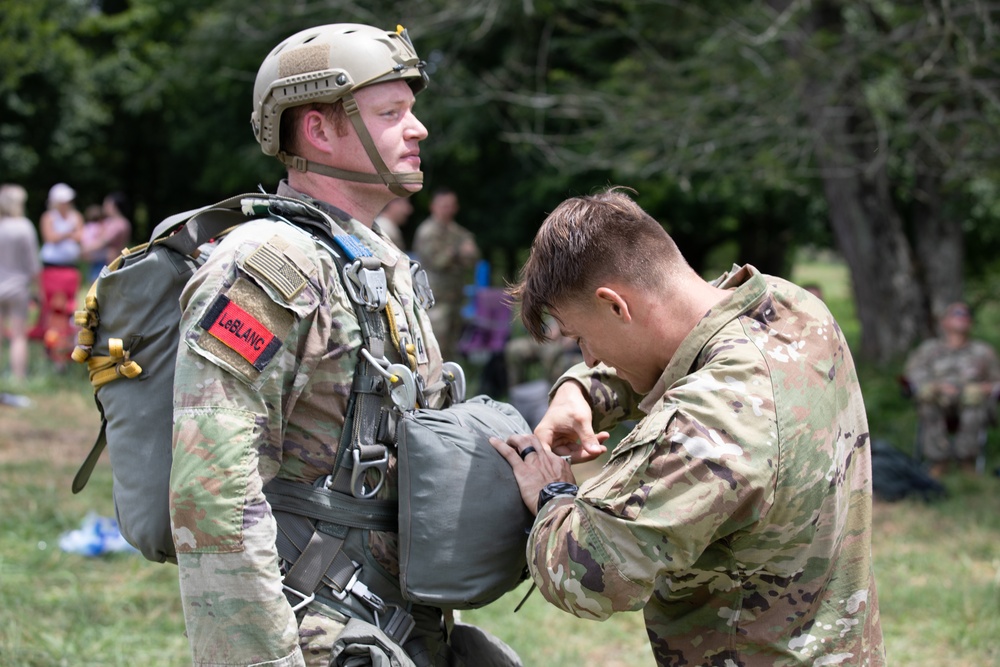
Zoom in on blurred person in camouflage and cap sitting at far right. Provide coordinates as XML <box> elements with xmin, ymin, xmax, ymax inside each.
<box><xmin>904</xmin><ymin>301</ymin><xmax>1000</xmax><ymax>477</ymax></box>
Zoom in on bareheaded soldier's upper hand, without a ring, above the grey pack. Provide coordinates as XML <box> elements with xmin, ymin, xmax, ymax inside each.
<box><xmin>535</xmin><ymin>381</ymin><xmax>610</xmax><ymax>463</ymax></box>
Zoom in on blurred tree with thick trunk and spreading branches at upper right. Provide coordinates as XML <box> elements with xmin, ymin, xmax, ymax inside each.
<box><xmin>462</xmin><ymin>0</ymin><xmax>1000</xmax><ymax>361</ymax></box>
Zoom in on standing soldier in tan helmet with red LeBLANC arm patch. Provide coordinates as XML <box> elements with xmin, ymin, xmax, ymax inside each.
<box><xmin>170</xmin><ymin>24</ymin><xmax>519</xmax><ymax>667</ymax></box>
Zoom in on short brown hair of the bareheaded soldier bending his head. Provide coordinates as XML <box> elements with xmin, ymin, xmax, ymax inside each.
<box><xmin>508</xmin><ymin>187</ymin><xmax>690</xmax><ymax>340</ymax></box>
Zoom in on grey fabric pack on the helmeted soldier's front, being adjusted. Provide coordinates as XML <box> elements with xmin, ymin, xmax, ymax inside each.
<box><xmin>397</xmin><ymin>396</ymin><xmax>534</xmax><ymax>609</ymax></box>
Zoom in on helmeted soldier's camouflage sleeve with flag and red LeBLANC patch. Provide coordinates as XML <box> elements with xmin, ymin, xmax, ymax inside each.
<box><xmin>170</xmin><ymin>223</ymin><xmax>325</xmax><ymax>667</ymax></box>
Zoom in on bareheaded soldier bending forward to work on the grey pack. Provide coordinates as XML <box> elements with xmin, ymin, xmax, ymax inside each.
<box><xmin>491</xmin><ymin>189</ymin><xmax>885</xmax><ymax>667</ymax></box>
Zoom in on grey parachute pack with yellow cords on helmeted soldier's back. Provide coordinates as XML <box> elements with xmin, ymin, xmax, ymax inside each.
<box><xmin>73</xmin><ymin>197</ymin><xmax>254</xmax><ymax>562</ymax></box>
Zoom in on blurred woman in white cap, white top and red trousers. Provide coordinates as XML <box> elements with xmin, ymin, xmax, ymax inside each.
<box><xmin>31</xmin><ymin>183</ymin><xmax>84</xmax><ymax>370</ymax></box>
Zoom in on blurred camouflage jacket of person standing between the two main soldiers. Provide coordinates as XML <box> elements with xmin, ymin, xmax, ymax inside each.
<box><xmin>413</xmin><ymin>218</ymin><xmax>479</xmax><ymax>303</ymax></box>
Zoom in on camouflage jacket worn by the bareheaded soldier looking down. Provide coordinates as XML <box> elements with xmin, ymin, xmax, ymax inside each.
<box><xmin>528</xmin><ymin>266</ymin><xmax>885</xmax><ymax>667</ymax></box>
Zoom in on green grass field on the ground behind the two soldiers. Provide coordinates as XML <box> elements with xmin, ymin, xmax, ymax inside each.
<box><xmin>0</xmin><ymin>264</ymin><xmax>1000</xmax><ymax>667</ymax></box>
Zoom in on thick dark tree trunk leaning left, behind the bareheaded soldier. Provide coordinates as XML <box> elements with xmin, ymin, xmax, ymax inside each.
<box><xmin>789</xmin><ymin>0</ymin><xmax>930</xmax><ymax>364</ymax></box>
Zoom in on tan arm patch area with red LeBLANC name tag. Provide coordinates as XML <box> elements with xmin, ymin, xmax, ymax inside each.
<box><xmin>198</xmin><ymin>278</ymin><xmax>294</xmax><ymax>382</ymax></box>
